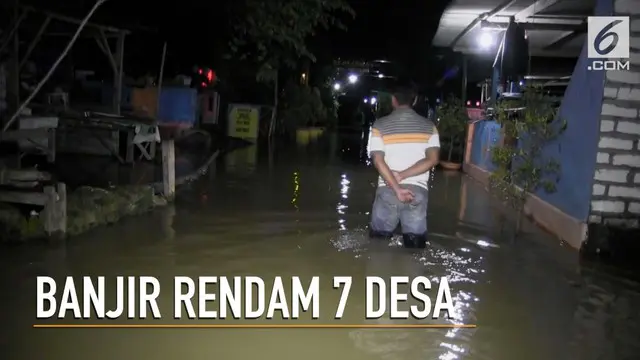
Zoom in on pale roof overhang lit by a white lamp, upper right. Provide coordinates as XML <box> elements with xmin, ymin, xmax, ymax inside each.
<box><xmin>433</xmin><ymin>0</ymin><xmax>595</xmax><ymax>57</ymax></box>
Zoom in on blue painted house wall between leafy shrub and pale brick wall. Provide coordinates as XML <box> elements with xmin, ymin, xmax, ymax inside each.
<box><xmin>537</xmin><ymin>0</ymin><xmax>613</xmax><ymax>221</ymax></box>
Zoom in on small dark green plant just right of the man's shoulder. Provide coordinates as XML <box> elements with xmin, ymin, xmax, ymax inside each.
<box><xmin>437</xmin><ymin>95</ymin><xmax>469</xmax><ymax>162</ymax></box>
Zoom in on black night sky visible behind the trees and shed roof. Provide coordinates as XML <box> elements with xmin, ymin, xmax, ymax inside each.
<box><xmin>16</xmin><ymin>0</ymin><xmax>571</xmax><ymax>98</ymax></box>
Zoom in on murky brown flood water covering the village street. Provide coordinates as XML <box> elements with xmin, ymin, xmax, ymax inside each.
<box><xmin>0</xmin><ymin>135</ymin><xmax>640</xmax><ymax>360</ymax></box>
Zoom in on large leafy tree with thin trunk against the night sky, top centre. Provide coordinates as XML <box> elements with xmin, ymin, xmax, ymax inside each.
<box><xmin>229</xmin><ymin>0</ymin><xmax>355</xmax><ymax>136</ymax></box>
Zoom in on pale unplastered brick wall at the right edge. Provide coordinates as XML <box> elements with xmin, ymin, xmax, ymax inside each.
<box><xmin>589</xmin><ymin>5</ymin><xmax>640</xmax><ymax>227</ymax></box>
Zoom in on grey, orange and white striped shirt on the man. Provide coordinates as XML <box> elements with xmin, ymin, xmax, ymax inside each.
<box><xmin>368</xmin><ymin>108</ymin><xmax>440</xmax><ymax>189</ymax></box>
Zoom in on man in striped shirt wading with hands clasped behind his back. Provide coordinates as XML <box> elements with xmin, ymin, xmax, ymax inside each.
<box><xmin>368</xmin><ymin>86</ymin><xmax>440</xmax><ymax>248</ymax></box>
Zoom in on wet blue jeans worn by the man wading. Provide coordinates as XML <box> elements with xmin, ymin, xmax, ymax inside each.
<box><xmin>371</xmin><ymin>185</ymin><xmax>429</xmax><ymax>248</ymax></box>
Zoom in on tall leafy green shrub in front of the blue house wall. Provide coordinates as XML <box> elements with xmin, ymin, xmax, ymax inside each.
<box><xmin>490</xmin><ymin>87</ymin><xmax>567</xmax><ymax>233</ymax></box>
